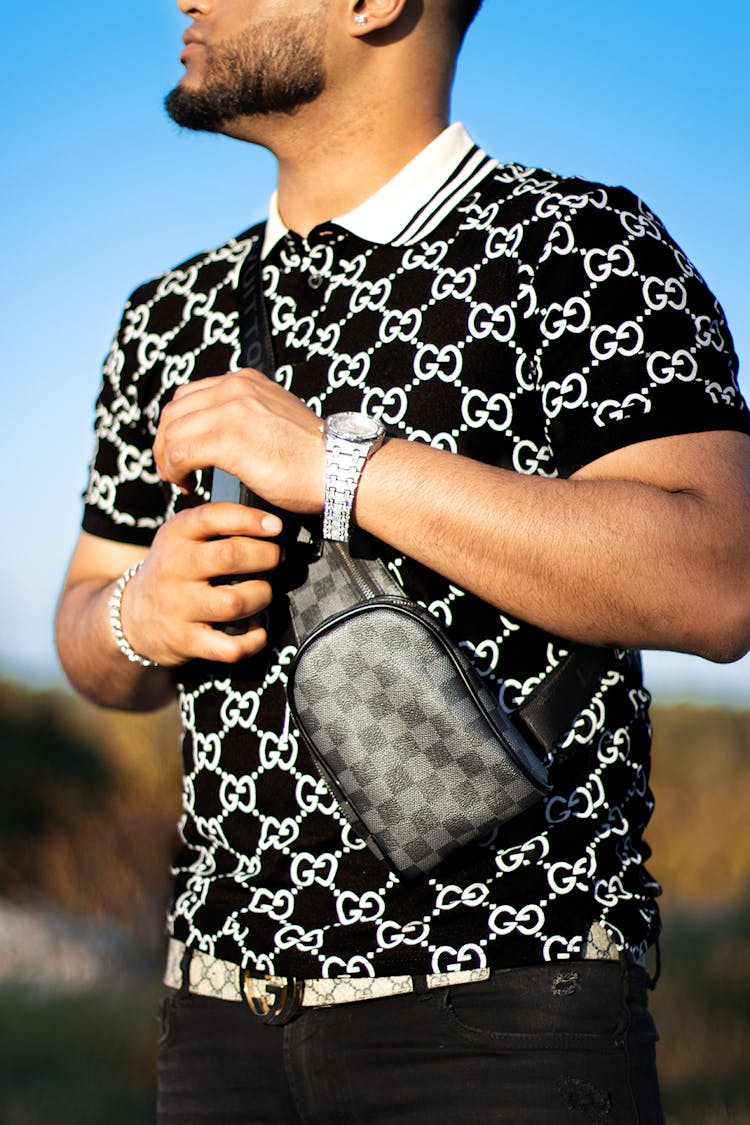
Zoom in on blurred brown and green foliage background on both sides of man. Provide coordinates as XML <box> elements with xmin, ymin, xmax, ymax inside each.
<box><xmin>0</xmin><ymin>682</ymin><xmax>750</xmax><ymax>1125</ymax></box>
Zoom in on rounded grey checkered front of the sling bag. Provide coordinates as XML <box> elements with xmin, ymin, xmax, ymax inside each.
<box><xmin>284</xmin><ymin>597</ymin><xmax>548</xmax><ymax>880</ymax></box>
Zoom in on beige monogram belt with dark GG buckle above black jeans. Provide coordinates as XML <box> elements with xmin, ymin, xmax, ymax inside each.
<box><xmin>164</xmin><ymin>926</ymin><xmax>618</xmax><ymax>1024</ymax></box>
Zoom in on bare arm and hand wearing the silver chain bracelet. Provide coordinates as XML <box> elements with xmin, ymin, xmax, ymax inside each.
<box><xmin>56</xmin><ymin>504</ymin><xmax>280</xmax><ymax>711</ymax></box>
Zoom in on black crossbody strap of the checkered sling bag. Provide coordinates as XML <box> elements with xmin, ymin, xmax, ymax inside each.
<box><xmin>237</xmin><ymin>224</ymin><xmax>614</xmax><ymax>762</ymax></box>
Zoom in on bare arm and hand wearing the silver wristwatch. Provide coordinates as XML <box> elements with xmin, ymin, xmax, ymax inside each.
<box><xmin>154</xmin><ymin>371</ymin><xmax>750</xmax><ymax>660</ymax></box>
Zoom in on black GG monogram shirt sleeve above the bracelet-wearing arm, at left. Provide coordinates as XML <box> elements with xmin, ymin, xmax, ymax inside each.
<box><xmin>82</xmin><ymin>281</ymin><xmax>169</xmax><ymax>546</ymax></box>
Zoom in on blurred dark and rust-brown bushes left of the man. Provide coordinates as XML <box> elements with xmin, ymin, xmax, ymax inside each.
<box><xmin>0</xmin><ymin>683</ymin><xmax>180</xmax><ymax>946</ymax></box>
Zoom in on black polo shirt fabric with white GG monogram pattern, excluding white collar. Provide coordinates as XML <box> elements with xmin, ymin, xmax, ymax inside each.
<box><xmin>84</xmin><ymin>138</ymin><xmax>748</xmax><ymax>979</ymax></box>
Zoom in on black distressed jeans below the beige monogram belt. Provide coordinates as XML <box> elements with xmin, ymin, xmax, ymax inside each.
<box><xmin>157</xmin><ymin>961</ymin><xmax>663</xmax><ymax>1125</ymax></box>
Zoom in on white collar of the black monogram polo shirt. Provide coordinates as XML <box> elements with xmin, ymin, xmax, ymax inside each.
<box><xmin>262</xmin><ymin>122</ymin><xmax>475</xmax><ymax>258</ymax></box>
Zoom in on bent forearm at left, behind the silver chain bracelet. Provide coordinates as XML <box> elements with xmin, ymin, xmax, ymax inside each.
<box><xmin>55</xmin><ymin>578</ymin><xmax>174</xmax><ymax>711</ymax></box>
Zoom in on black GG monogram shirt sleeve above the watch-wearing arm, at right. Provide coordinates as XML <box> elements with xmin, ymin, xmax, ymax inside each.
<box><xmin>524</xmin><ymin>181</ymin><xmax>750</xmax><ymax>477</ymax></box>
